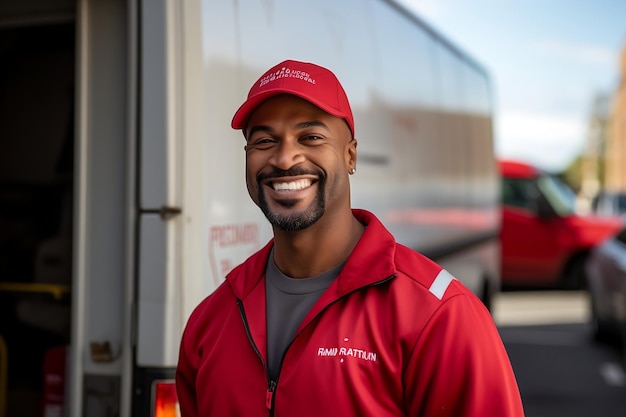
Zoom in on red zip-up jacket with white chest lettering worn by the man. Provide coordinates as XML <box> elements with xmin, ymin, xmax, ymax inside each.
<box><xmin>176</xmin><ymin>210</ymin><xmax>523</xmax><ymax>417</ymax></box>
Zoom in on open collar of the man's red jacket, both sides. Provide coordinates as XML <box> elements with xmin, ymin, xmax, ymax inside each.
<box><xmin>226</xmin><ymin>209</ymin><xmax>396</xmax><ymax>300</ymax></box>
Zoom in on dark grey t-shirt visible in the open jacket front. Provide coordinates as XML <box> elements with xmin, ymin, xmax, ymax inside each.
<box><xmin>265</xmin><ymin>249</ymin><xmax>345</xmax><ymax>381</ymax></box>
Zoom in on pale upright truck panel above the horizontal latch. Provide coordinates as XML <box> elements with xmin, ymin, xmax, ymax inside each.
<box><xmin>139</xmin><ymin>0</ymin><xmax>183</xmax><ymax>209</ymax></box>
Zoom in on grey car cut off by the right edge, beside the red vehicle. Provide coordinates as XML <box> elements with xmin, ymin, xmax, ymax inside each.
<box><xmin>585</xmin><ymin>224</ymin><xmax>626</xmax><ymax>348</ymax></box>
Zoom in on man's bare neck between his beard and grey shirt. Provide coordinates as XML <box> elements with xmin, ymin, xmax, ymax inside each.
<box><xmin>274</xmin><ymin>212</ymin><xmax>365</xmax><ymax>278</ymax></box>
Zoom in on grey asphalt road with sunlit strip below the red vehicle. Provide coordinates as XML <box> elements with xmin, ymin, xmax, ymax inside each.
<box><xmin>493</xmin><ymin>291</ymin><xmax>626</xmax><ymax>417</ymax></box>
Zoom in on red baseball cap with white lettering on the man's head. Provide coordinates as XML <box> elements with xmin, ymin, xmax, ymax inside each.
<box><xmin>231</xmin><ymin>60</ymin><xmax>354</xmax><ymax>136</ymax></box>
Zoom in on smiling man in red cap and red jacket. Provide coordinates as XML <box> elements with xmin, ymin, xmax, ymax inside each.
<box><xmin>176</xmin><ymin>61</ymin><xmax>523</xmax><ymax>417</ymax></box>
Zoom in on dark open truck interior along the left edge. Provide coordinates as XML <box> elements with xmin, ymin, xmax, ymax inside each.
<box><xmin>0</xmin><ymin>8</ymin><xmax>76</xmax><ymax>417</ymax></box>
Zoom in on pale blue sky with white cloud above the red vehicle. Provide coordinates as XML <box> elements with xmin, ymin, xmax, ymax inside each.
<box><xmin>397</xmin><ymin>0</ymin><xmax>626</xmax><ymax>172</ymax></box>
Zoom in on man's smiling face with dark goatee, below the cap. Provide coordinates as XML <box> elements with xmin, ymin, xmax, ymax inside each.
<box><xmin>244</xmin><ymin>94</ymin><xmax>356</xmax><ymax>231</ymax></box>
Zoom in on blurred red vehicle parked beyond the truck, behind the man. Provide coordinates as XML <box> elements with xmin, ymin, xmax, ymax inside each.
<box><xmin>499</xmin><ymin>160</ymin><xmax>622</xmax><ymax>289</ymax></box>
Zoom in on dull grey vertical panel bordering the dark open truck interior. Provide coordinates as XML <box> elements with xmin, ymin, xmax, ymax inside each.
<box><xmin>73</xmin><ymin>1</ymin><xmax>128</xmax><ymax>374</ymax></box>
